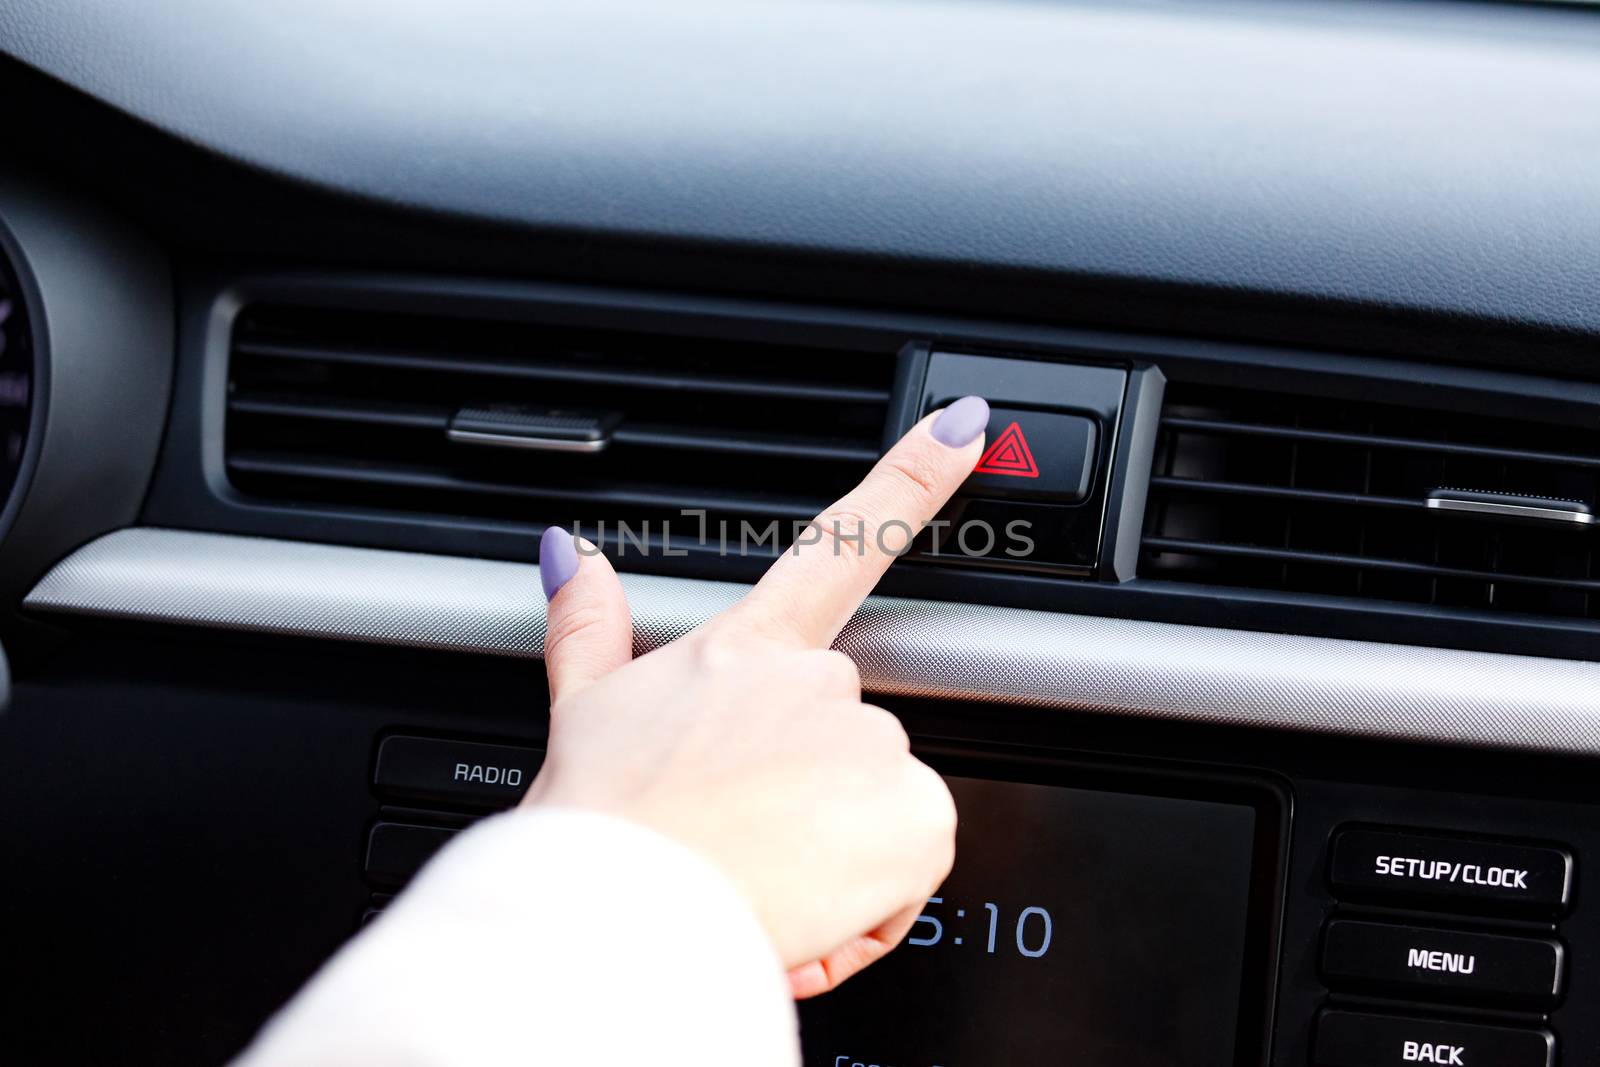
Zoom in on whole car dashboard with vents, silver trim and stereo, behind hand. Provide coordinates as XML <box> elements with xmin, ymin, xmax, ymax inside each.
<box><xmin>0</xmin><ymin>0</ymin><xmax>1600</xmax><ymax>1067</ymax></box>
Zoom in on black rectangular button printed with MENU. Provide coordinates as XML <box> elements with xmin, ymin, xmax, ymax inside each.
<box><xmin>1322</xmin><ymin>918</ymin><xmax>1563</xmax><ymax>1006</ymax></box>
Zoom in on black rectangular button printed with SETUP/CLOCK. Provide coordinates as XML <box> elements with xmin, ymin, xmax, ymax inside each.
<box><xmin>1328</xmin><ymin>829</ymin><xmax>1573</xmax><ymax>913</ymax></box>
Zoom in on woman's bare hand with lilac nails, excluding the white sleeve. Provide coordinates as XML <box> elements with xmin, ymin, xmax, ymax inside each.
<box><xmin>523</xmin><ymin>397</ymin><xmax>989</xmax><ymax>997</ymax></box>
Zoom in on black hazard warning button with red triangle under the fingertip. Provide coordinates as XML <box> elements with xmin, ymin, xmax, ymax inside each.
<box><xmin>962</xmin><ymin>408</ymin><xmax>1099</xmax><ymax>504</ymax></box>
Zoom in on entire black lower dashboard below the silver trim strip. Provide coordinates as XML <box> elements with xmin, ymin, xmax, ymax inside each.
<box><xmin>0</xmin><ymin>624</ymin><xmax>1600</xmax><ymax>1067</ymax></box>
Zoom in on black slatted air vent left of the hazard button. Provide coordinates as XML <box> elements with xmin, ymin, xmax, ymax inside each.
<box><xmin>226</xmin><ymin>307</ymin><xmax>894</xmax><ymax>542</ymax></box>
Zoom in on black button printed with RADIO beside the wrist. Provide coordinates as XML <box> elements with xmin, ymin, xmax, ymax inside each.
<box><xmin>373</xmin><ymin>736</ymin><xmax>544</xmax><ymax>808</ymax></box>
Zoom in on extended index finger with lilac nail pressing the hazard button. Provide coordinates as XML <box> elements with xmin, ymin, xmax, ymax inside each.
<box><xmin>736</xmin><ymin>397</ymin><xmax>989</xmax><ymax>648</ymax></box>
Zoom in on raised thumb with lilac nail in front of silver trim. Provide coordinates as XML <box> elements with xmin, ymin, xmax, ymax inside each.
<box><xmin>539</xmin><ymin>526</ymin><xmax>634</xmax><ymax>704</ymax></box>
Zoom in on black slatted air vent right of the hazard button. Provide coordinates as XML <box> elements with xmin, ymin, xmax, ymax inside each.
<box><xmin>1139</xmin><ymin>386</ymin><xmax>1600</xmax><ymax>619</ymax></box>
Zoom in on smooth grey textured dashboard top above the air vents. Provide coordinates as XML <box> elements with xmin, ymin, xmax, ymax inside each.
<box><xmin>0</xmin><ymin>0</ymin><xmax>1600</xmax><ymax>333</ymax></box>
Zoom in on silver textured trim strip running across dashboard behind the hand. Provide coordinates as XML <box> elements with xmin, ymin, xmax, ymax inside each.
<box><xmin>26</xmin><ymin>528</ymin><xmax>1600</xmax><ymax>755</ymax></box>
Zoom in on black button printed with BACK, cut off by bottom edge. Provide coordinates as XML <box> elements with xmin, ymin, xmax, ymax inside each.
<box><xmin>1312</xmin><ymin>1011</ymin><xmax>1555</xmax><ymax>1067</ymax></box>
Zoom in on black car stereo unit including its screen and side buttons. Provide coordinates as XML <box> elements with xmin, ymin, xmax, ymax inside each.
<box><xmin>321</xmin><ymin>675</ymin><xmax>1600</xmax><ymax>1067</ymax></box>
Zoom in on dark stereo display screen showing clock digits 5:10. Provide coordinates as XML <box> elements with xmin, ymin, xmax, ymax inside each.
<box><xmin>800</xmin><ymin>777</ymin><xmax>1258</xmax><ymax>1067</ymax></box>
